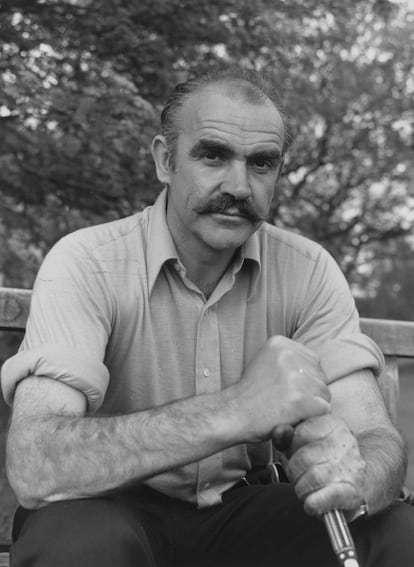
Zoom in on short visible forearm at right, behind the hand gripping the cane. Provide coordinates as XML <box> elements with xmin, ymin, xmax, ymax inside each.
<box><xmin>357</xmin><ymin>428</ymin><xmax>407</xmax><ymax>514</ymax></box>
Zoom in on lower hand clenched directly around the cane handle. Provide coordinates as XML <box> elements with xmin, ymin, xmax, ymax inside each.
<box><xmin>287</xmin><ymin>414</ymin><xmax>366</xmax><ymax>515</ymax></box>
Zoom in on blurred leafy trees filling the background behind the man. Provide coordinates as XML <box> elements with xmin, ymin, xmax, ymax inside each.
<box><xmin>0</xmin><ymin>0</ymin><xmax>414</xmax><ymax>539</ymax></box>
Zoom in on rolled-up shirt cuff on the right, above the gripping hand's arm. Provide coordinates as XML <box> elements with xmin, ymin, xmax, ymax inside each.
<box><xmin>318</xmin><ymin>333</ymin><xmax>385</xmax><ymax>384</ymax></box>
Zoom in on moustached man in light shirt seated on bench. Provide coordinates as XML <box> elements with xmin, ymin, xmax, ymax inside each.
<box><xmin>2</xmin><ymin>65</ymin><xmax>414</xmax><ymax>567</ymax></box>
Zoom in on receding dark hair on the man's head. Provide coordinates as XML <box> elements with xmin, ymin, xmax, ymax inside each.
<box><xmin>161</xmin><ymin>66</ymin><xmax>293</xmax><ymax>167</ymax></box>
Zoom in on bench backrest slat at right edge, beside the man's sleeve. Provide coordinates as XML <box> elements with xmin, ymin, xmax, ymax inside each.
<box><xmin>361</xmin><ymin>318</ymin><xmax>414</xmax><ymax>358</ymax></box>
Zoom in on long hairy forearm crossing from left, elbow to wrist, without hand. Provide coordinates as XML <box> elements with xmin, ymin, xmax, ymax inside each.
<box><xmin>7</xmin><ymin>394</ymin><xmax>237</xmax><ymax>507</ymax></box>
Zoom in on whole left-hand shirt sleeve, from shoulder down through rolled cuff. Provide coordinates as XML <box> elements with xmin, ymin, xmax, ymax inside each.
<box><xmin>1</xmin><ymin>236</ymin><xmax>112</xmax><ymax>411</ymax></box>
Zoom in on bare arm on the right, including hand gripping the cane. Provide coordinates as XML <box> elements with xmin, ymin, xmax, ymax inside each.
<box><xmin>288</xmin><ymin>371</ymin><xmax>406</xmax><ymax>514</ymax></box>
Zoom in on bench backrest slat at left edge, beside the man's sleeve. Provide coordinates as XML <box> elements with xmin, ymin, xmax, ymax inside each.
<box><xmin>0</xmin><ymin>287</ymin><xmax>32</xmax><ymax>331</ymax></box>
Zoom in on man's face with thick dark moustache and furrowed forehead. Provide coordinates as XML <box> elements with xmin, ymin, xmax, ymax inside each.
<box><xmin>155</xmin><ymin>87</ymin><xmax>284</xmax><ymax>255</ymax></box>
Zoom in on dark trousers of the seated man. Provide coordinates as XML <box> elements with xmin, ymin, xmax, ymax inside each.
<box><xmin>11</xmin><ymin>484</ymin><xmax>414</xmax><ymax>567</ymax></box>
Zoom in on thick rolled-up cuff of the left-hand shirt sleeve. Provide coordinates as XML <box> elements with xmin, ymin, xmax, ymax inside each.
<box><xmin>1</xmin><ymin>344</ymin><xmax>109</xmax><ymax>412</ymax></box>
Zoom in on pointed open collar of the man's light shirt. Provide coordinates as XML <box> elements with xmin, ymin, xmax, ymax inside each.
<box><xmin>147</xmin><ymin>189</ymin><xmax>261</xmax><ymax>295</ymax></box>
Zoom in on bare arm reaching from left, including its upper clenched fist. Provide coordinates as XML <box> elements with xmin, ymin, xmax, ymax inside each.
<box><xmin>7</xmin><ymin>337</ymin><xmax>330</xmax><ymax>507</ymax></box>
